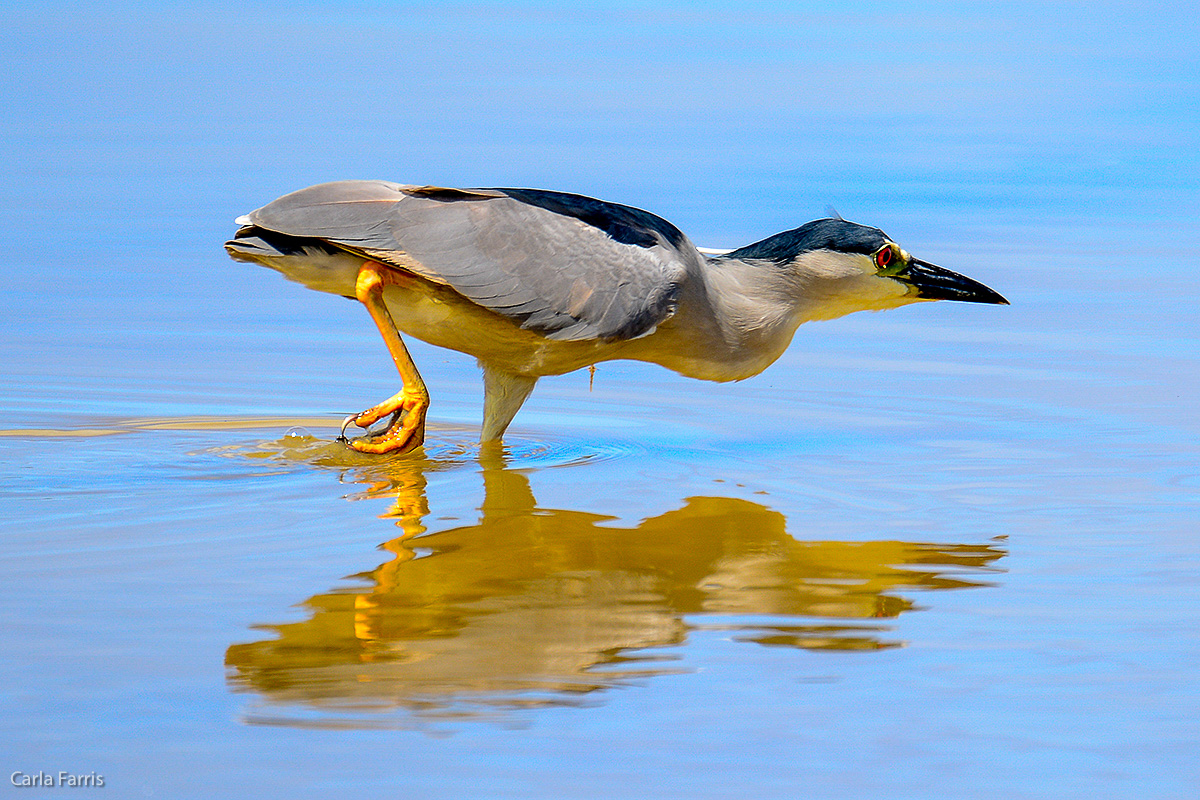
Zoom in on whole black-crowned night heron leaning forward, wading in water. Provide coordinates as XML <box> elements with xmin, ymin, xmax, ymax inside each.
<box><xmin>226</xmin><ymin>181</ymin><xmax>1008</xmax><ymax>452</ymax></box>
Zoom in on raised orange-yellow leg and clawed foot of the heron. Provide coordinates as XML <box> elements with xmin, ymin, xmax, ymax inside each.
<box><xmin>342</xmin><ymin>261</ymin><xmax>430</xmax><ymax>453</ymax></box>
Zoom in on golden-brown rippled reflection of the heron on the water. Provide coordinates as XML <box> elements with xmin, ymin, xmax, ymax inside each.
<box><xmin>226</xmin><ymin>434</ymin><xmax>1003</xmax><ymax>714</ymax></box>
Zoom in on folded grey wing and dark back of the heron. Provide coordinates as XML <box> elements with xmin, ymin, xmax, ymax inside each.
<box><xmin>248</xmin><ymin>181</ymin><xmax>700</xmax><ymax>339</ymax></box>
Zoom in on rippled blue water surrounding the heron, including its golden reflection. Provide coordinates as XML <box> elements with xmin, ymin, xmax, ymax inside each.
<box><xmin>0</xmin><ymin>2</ymin><xmax>1200</xmax><ymax>800</ymax></box>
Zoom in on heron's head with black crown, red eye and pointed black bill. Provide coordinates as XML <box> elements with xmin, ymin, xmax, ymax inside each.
<box><xmin>726</xmin><ymin>219</ymin><xmax>1008</xmax><ymax>319</ymax></box>
